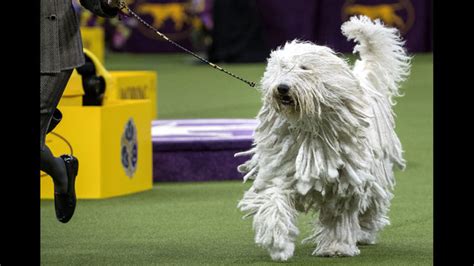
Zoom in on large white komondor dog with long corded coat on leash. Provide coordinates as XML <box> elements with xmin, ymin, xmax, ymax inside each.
<box><xmin>236</xmin><ymin>16</ymin><xmax>411</xmax><ymax>261</ymax></box>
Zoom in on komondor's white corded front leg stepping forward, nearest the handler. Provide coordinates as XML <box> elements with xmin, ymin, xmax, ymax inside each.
<box><xmin>238</xmin><ymin>186</ymin><xmax>299</xmax><ymax>261</ymax></box>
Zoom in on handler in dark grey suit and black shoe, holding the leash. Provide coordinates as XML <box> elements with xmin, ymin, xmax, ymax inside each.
<box><xmin>40</xmin><ymin>0</ymin><xmax>120</xmax><ymax>223</ymax></box>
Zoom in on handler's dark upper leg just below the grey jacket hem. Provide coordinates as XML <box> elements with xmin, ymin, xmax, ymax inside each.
<box><xmin>40</xmin><ymin>69</ymin><xmax>72</xmax><ymax>150</ymax></box>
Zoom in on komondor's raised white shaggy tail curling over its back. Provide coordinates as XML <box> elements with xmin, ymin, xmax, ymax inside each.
<box><xmin>341</xmin><ymin>16</ymin><xmax>411</xmax><ymax>102</ymax></box>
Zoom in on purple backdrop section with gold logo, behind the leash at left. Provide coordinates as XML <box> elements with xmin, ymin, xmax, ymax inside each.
<box><xmin>73</xmin><ymin>0</ymin><xmax>212</xmax><ymax>53</ymax></box>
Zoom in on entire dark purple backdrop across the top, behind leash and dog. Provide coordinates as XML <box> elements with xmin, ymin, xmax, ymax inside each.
<box><xmin>75</xmin><ymin>0</ymin><xmax>432</xmax><ymax>59</ymax></box>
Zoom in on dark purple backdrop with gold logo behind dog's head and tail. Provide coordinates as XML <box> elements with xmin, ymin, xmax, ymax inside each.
<box><xmin>257</xmin><ymin>0</ymin><xmax>432</xmax><ymax>52</ymax></box>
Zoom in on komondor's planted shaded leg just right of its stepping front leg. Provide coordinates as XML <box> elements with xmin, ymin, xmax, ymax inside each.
<box><xmin>303</xmin><ymin>186</ymin><xmax>360</xmax><ymax>257</ymax></box>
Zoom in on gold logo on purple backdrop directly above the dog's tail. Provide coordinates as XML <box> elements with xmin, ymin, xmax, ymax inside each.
<box><xmin>342</xmin><ymin>0</ymin><xmax>415</xmax><ymax>34</ymax></box>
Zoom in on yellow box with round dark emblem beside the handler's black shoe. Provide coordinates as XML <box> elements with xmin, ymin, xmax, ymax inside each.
<box><xmin>41</xmin><ymin>100</ymin><xmax>153</xmax><ymax>199</ymax></box>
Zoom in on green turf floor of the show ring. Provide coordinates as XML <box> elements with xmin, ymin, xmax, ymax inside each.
<box><xmin>41</xmin><ymin>54</ymin><xmax>433</xmax><ymax>265</ymax></box>
